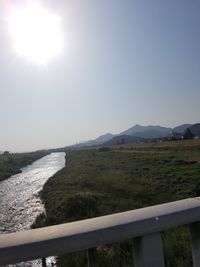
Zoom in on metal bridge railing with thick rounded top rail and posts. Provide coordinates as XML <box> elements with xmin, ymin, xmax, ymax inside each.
<box><xmin>0</xmin><ymin>198</ymin><xmax>200</xmax><ymax>267</ymax></box>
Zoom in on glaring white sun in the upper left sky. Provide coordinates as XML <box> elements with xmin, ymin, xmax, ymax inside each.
<box><xmin>8</xmin><ymin>0</ymin><xmax>63</xmax><ymax>65</ymax></box>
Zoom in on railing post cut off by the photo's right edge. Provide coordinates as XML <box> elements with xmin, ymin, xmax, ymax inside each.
<box><xmin>190</xmin><ymin>222</ymin><xmax>200</xmax><ymax>267</ymax></box>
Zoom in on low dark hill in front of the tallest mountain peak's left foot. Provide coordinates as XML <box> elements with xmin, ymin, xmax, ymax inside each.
<box><xmin>103</xmin><ymin>134</ymin><xmax>144</xmax><ymax>146</ymax></box>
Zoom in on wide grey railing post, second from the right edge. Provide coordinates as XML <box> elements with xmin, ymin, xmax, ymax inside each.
<box><xmin>133</xmin><ymin>233</ymin><xmax>165</xmax><ymax>267</ymax></box>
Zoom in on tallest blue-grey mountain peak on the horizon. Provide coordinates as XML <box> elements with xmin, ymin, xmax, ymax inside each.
<box><xmin>120</xmin><ymin>124</ymin><xmax>172</xmax><ymax>138</ymax></box>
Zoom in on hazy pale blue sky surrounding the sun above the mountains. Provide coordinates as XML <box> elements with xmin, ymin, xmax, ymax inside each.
<box><xmin>0</xmin><ymin>0</ymin><xmax>200</xmax><ymax>151</ymax></box>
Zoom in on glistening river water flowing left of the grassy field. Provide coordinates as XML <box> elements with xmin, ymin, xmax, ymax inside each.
<box><xmin>0</xmin><ymin>152</ymin><xmax>65</xmax><ymax>266</ymax></box>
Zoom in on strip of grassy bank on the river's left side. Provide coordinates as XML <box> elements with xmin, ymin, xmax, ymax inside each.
<box><xmin>0</xmin><ymin>151</ymin><xmax>47</xmax><ymax>181</ymax></box>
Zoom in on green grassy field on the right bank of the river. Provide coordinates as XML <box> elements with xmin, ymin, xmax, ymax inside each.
<box><xmin>35</xmin><ymin>140</ymin><xmax>200</xmax><ymax>267</ymax></box>
